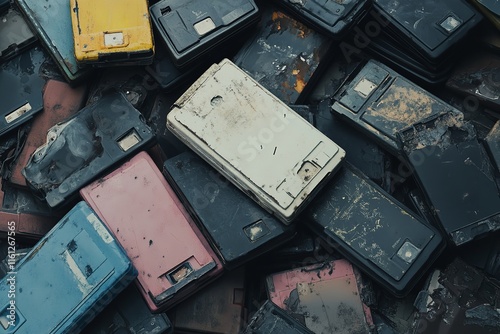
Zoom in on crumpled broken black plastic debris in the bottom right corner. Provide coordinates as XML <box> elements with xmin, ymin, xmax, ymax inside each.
<box><xmin>411</xmin><ymin>258</ymin><xmax>500</xmax><ymax>334</ymax></box>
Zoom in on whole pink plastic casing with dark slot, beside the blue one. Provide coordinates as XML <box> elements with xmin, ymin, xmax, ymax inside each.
<box><xmin>80</xmin><ymin>152</ymin><xmax>223</xmax><ymax>312</ymax></box>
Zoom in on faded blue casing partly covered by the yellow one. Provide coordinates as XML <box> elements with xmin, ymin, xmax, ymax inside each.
<box><xmin>16</xmin><ymin>0</ymin><xmax>89</xmax><ymax>81</ymax></box>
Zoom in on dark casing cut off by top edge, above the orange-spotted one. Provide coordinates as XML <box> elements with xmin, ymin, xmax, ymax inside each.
<box><xmin>278</xmin><ymin>0</ymin><xmax>371</xmax><ymax>39</ymax></box>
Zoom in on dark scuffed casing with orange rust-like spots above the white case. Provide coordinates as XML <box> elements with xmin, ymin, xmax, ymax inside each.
<box><xmin>233</xmin><ymin>4</ymin><xmax>332</xmax><ymax>104</ymax></box>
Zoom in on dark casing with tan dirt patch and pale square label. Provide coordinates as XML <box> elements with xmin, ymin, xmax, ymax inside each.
<box><xmin>332</xmin><ymin>60</ymin><xmax>454</xmax><ymax>154</ymax></box>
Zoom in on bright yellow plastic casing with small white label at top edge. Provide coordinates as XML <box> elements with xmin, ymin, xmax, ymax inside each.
<box><xmin>70</xmin><ymin>0</ymin><xmax>154</xmax><ymax>66</ymax></box>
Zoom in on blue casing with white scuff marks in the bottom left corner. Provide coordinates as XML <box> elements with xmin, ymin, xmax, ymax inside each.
<box><xmin>0</xmin><ymin>202</ymin><xmax>137</xmax><ymax>334</ymax></box>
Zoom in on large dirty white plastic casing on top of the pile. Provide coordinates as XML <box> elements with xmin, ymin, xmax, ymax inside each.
<box><xmin>167</xmin><ymin>59</ymin><xmax>345</xmax><ymax>224</ymax></box>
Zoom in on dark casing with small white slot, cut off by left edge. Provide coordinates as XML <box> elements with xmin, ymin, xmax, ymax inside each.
<box><xmin>0</xmin><ymin>46</ymin><xmax>49</xmax><ymax>136</ymax></box>
